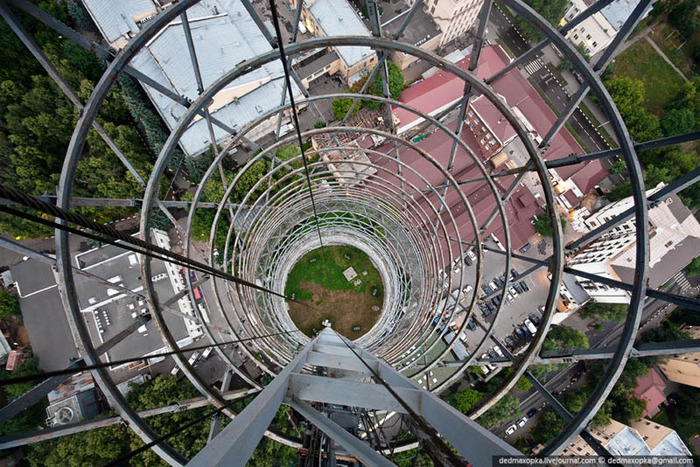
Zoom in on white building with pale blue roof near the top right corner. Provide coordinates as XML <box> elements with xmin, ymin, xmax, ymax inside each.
<box><xmin>561</xmin><ymin>0</ymin><xmax>651</xmax><ymax>56</ymax></box>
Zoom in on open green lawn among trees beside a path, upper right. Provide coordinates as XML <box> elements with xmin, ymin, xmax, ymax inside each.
<box><xmin>615</xmin><ymin>39</ymin><xmax>683</xmax><ymax>117</ymax></box>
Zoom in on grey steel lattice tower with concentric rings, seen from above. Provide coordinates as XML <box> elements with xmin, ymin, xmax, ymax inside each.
<box><xmin>0</xmin><ymin>0</ymin><xmax>700</xmax><ymax>465</ymax></box>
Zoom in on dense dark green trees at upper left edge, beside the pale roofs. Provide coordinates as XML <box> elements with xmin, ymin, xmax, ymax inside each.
<box><xmin>0</xmin><ymin>10</ymin><xmax>156</xmax><ymax>238</ymax></box>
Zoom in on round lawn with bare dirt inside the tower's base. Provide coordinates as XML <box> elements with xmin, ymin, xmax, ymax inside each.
<box><xmin>285</xmin><ymin>245</ymin><xmax>384</xmax><ymax>339</ymax></box>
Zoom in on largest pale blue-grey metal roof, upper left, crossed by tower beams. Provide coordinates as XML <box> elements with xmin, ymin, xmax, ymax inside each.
<box><xmin>125</xmin><ymin>0</ymin><xmax>302</xmax><ymax>155</ymax></box>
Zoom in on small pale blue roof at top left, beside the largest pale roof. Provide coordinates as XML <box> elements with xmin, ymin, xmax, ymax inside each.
<box><xmin>83</xmin><ymin>0</ymin><xmax>156</xmax><ymax>43</ymax></box>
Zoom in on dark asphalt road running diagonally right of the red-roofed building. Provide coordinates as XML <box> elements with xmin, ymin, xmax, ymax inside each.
<box><xmin>489</xmin><ymin>8</ymin><xmax>608</xmax><ymax>152</ymax></box>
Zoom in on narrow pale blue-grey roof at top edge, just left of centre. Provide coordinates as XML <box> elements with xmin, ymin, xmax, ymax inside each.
<box><xmin>309</xmin><ymin>0</ymin><xmax>374</xmax><ymax>67</ymax></box>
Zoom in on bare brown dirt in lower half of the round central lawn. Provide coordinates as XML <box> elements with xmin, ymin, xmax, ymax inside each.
<box><xmin>289</xmin><ymin>282</ymin><xmax>383</xmax><ymax>339</ymax></box>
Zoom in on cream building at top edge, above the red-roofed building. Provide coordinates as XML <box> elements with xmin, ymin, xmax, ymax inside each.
<box><xmin>418</xmin><ymin>0</ymin><xmax>484</xmax><ymax>47</ymax></box>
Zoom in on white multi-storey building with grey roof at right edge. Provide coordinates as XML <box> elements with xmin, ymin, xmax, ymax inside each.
<box><xmin>569</xmin><ymin>183</ymin><xmax>700</xmax><ymax>303</ymax></box>
